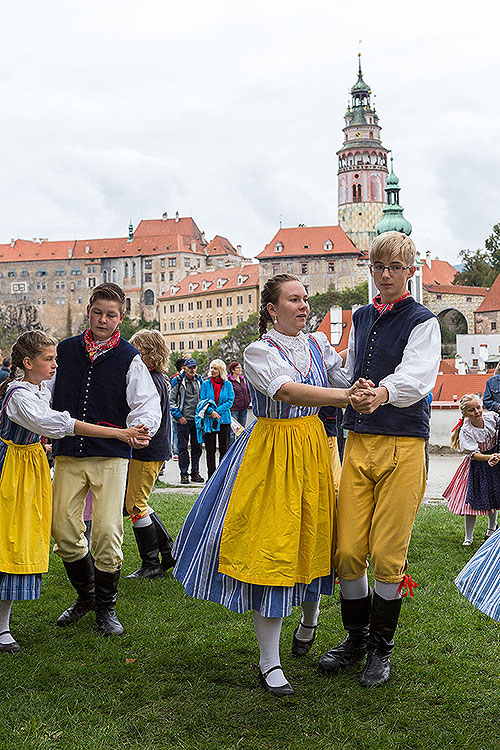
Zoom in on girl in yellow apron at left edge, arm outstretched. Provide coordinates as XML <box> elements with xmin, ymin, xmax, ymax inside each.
<box><xmin>0</xmin><ymin>331</ymin><xmax>149</xmax><ymax>653</ymax></box>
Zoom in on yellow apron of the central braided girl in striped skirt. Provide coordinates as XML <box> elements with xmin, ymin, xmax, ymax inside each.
<box><xmin>219</xmin><ymin>416</ymin><xmax>335</xmax><ymax>586</ymax></box>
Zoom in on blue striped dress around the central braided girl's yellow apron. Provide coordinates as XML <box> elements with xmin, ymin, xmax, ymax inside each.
<box><xmin>173</xmin><ymin>336</ymin><xmax>335</xmax><ymax>617</ymax></box>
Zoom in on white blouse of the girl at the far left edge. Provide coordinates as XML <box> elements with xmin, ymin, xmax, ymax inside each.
<box><xmin>6</xmin><ymin>380</ymin><xmax>75</xmax><ymax>439</ymax></box>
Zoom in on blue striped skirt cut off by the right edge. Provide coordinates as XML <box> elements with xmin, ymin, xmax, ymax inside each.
<box><xmin>455</xmin><ymin>531</ymin><xmax>500</xmax><ymax>621</ymax></box>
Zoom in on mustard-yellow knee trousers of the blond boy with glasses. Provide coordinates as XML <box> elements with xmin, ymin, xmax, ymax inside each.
<box><xmin>335</xmin><ymin>432</ymin><xmax>425</xmax><ymax>583</ymax></box>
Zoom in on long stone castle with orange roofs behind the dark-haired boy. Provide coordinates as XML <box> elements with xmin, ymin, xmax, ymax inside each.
<box><xmin>0</xmin><ymin>214</ymin><xmax>248</xmax><ymax>337</ymax></box>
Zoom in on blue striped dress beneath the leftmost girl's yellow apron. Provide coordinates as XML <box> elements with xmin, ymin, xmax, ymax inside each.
<box><xmin>0</xmin><ymin>386</ymin><xmax>42</xmax><ymax>600</ymax></box>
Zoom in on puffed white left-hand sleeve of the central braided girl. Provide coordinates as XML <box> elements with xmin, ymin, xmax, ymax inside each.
<box><xmin>243</xmin><ymin>341</ymin><xmax>295</xmax><ymax>398</ymax></box>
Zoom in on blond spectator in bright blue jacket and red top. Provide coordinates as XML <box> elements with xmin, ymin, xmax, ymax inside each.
<box><xmin>197</xmin><ymin>359</ymin><xmax>234</xmax><ymax>478</ymax></box>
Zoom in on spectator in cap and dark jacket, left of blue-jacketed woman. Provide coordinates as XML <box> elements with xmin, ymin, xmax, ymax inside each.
<box><xmin>170</xmin><ymin>357</ymin><xmax>205</xmax><ymax>484</ymax></box>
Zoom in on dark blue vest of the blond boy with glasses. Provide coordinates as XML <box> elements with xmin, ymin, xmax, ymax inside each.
<box><xmin>343</xmin><ymin>297</ymin><xmax>435</xmax><ymax>439</ymax></box>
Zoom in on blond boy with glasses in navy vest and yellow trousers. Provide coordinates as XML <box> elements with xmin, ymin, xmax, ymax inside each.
<box><xmin>319</xmin><ymin>232</ymin><xmax>441</xmax><ymax>687</ymax></box>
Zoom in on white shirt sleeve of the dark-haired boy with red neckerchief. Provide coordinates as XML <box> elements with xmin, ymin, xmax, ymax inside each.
<box><xmin>126</xmin><ymin>354</ymin><xmax>161</xmax><ymax>437</ymax></box>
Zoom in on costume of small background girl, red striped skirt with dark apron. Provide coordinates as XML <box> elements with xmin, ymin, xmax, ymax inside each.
<box><xmin>443</xmin><ymin>411</ymin><xmax>500</xmax><ymax>543</ymax></box>
